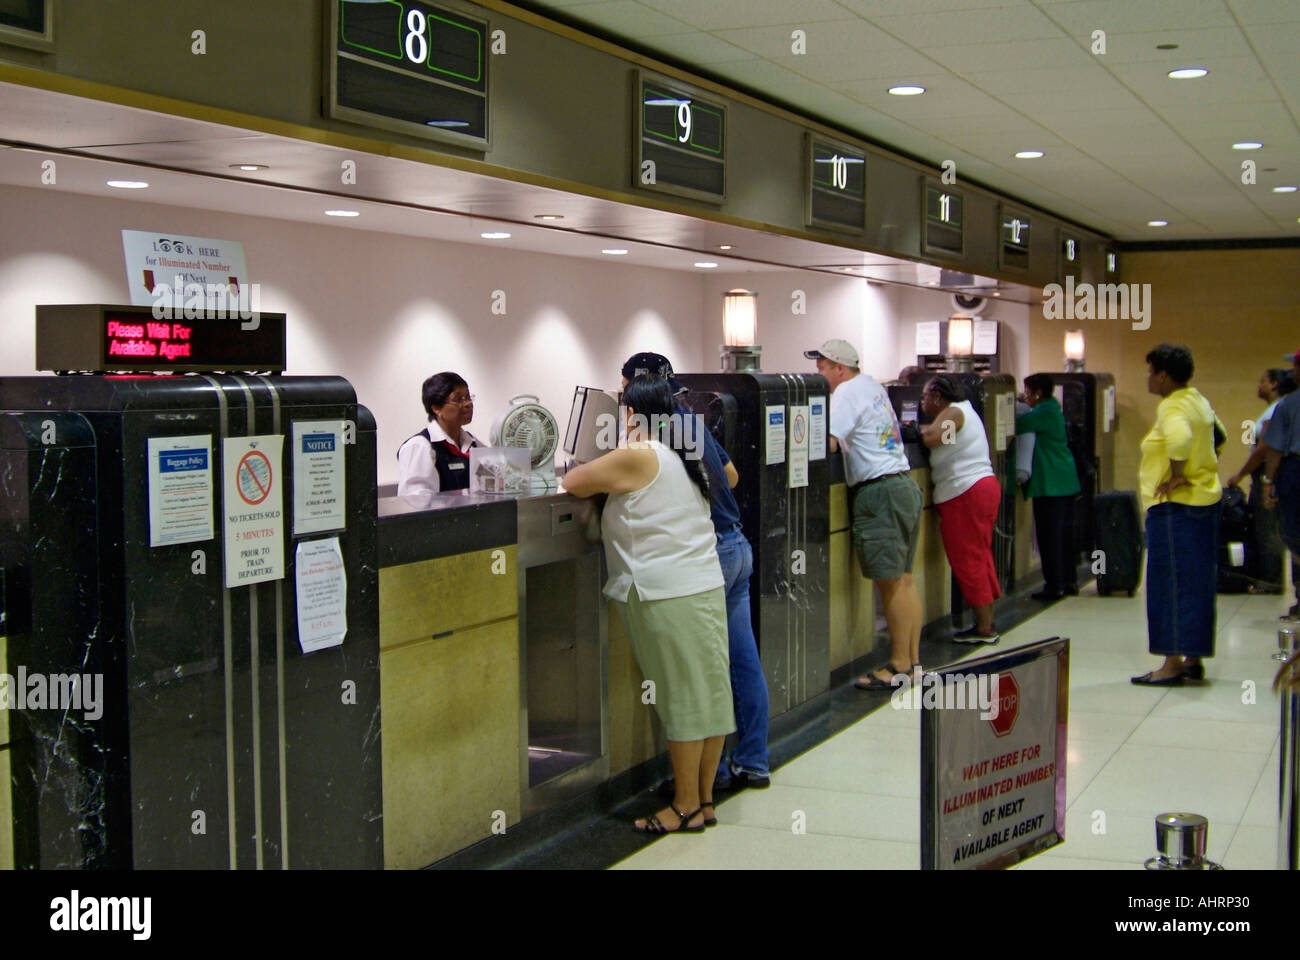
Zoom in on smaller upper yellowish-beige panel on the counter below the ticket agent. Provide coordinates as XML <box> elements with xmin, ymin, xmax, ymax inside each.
<box><xmin>380</xmin><ymin>545</ymin><xmax>519</xmax><ymax>649</ymax></box>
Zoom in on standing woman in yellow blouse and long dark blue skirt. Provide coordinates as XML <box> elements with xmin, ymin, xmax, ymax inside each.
<box><xmin>1132</xmin><ymin>343</ymin><xmax>1223</xmax><ymax>687</ymax></box>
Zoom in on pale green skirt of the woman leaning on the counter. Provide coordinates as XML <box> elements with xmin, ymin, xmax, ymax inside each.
<box><xmin>614</xmin><ymin>585</ymin><xmax>736</xmax><ymax>740</ymax></box>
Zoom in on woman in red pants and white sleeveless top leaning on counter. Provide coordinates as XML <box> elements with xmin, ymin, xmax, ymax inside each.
<box><xmin>920</xmin><ymin>376</ymin><xmax>1002</xmax><ymax>644</ymax></box>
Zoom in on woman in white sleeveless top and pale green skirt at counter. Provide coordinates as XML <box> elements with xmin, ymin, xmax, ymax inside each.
<box><xmin>564</xmin><ymin>373</ymin><xmax>736</xmax><ymax>834</ymax></box>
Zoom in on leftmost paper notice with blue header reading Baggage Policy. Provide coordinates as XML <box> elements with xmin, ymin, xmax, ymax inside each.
<box><xmin>147</xmin><ymin>433</ymin><xmax>216</xmax><ymax>546</ymax></box>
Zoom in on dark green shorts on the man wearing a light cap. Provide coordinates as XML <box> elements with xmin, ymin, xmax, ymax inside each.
<box><xmin>853</xmin><ymin>472</ymin><xmax>923</xmax><ymax>580</ymax></box>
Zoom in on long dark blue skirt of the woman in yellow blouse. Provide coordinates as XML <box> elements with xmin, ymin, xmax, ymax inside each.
<box><xmin>1147</xmin><ymin>503</ymin><xmax>1219</xmax><ymax>657</ymax></box>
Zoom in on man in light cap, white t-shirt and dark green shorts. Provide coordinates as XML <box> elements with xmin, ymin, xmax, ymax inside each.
<box><xmin>803</xmin><ymin>340</ymin><xmax>924</xmax><ymax>691</ymax></box>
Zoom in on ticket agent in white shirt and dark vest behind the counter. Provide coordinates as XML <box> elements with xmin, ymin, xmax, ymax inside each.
<box><xmin>398</xmin><ymin>371</ymin><xmax>480</xmax><ymax>497</ymax></box>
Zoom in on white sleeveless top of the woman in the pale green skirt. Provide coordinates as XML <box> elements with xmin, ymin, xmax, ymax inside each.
<box><xmin>601</xmin><ymin>440</ymin><xmax>725</xmax><ymax>602</ymax></box>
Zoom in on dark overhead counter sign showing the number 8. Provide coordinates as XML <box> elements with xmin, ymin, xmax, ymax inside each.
<box><xmin>326</xmin><ymin>0</ymin><xmax>489</xmax><ymax>150</ymax></box>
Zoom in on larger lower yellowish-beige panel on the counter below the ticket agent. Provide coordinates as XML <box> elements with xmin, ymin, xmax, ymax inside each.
<box><xmin>380</xmin><ymin>613</ymin><xmax>520</xmax><ymax>869</ymax></box>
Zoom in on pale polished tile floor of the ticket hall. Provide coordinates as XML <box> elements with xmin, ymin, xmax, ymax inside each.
<box><xmin>614</xmin><ymin>587</ymin><xmax>1290</xmax><ymax>870</ymax></box>
